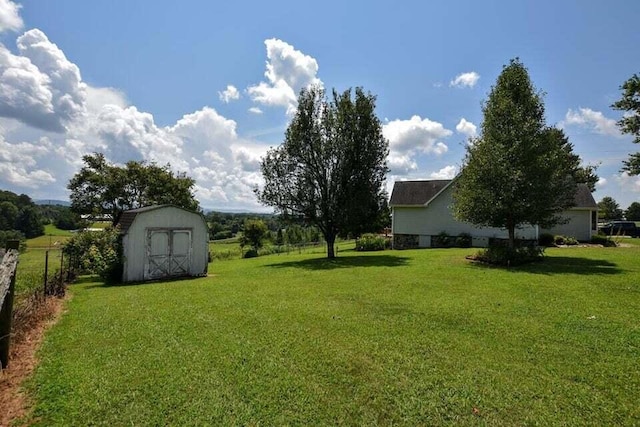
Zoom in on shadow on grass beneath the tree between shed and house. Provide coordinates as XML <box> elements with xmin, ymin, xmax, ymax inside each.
<box><xmin>266</xmin><ymin>255</ymin><xmax>410</xmax><ymax>270</ymax></box>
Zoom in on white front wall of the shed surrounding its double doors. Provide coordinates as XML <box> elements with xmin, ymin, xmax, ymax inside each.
<box><xmin>122</xmin><ymin>206</ymin><xmax>209</xmax><ymax>282</ymax></box>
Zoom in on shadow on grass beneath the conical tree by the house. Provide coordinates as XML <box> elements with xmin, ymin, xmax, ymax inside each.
<box><xmin>474</xmin><ymin>256</ymin><xmax>624</xmax><ymax>275</ymax></box>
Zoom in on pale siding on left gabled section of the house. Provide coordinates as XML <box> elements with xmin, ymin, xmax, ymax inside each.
<box><xmin>393</xmin><ymin>186</ymin><xmax>537</xmax><ymax>246</ymax></box>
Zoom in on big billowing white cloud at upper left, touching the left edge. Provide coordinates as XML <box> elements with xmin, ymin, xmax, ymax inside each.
<box><xmin>0</xmin><ymin>29</ymin><xmax>86</xmax><ymax>132</ymax></box>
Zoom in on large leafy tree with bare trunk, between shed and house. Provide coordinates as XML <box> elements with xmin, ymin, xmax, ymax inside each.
<box><xmin>256</xmin><ymin>86</ymin><xmax>389</xmax><ymax>258</ymax></box>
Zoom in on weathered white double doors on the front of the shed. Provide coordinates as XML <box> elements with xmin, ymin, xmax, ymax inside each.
<box><xmin>144</xmin><ymin>229</ymin><xmax>191</xmax><ymax>279</ymax></box>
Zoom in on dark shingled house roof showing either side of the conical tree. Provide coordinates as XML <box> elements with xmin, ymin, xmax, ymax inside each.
<box><xmin>389</xmin><ymin>179</ymin><xmax>598</xmax><ymax>209</ymax></box>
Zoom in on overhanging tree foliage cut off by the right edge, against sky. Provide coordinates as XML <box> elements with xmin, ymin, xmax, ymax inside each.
<box><xmin>611</xmin><ymin>74</ymin><xmax>640</xmax><ymax>175</ymax></box>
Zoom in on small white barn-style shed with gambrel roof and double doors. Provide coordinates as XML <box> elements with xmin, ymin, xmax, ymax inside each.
<box><xmin>118</xmin><ymin>205</ymin><xmax>209</xmax><ymax>282</ymax></box>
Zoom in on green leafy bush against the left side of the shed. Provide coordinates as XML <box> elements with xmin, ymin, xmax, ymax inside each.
<box><xmin>63</xmin><ymin>227</ymin><xmax>123</xmax><ymax>282</ymax></box>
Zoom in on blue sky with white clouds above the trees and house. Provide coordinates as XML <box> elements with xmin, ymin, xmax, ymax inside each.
<box><xmin>0</xmin><ymin>0</ymin><xmax>640</xmax><ymax>211</ymax></box>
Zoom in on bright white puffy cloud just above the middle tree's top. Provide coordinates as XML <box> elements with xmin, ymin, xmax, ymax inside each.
<box><xmin>247</xmin><ymin>39</ymin><xmax>322</xmax><ymax>114</ymax></box>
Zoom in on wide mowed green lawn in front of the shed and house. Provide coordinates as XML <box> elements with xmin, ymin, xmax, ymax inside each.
<box><xmin>28</xmin><ymin>245</ymin><xmax>640</xmax><ymax>425</ymax></box>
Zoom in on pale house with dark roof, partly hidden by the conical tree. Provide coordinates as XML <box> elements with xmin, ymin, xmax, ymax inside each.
<box><xmin>389</xmin><ymin>180</ymin><xmax>598</xmax><ymax>249</ymax></box>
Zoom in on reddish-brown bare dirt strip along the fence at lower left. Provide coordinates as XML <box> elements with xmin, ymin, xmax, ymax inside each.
<box><xmin>0</xmin><ymin>296</ymin><xmax>69</xmax><ymax>427</ymax></box>
